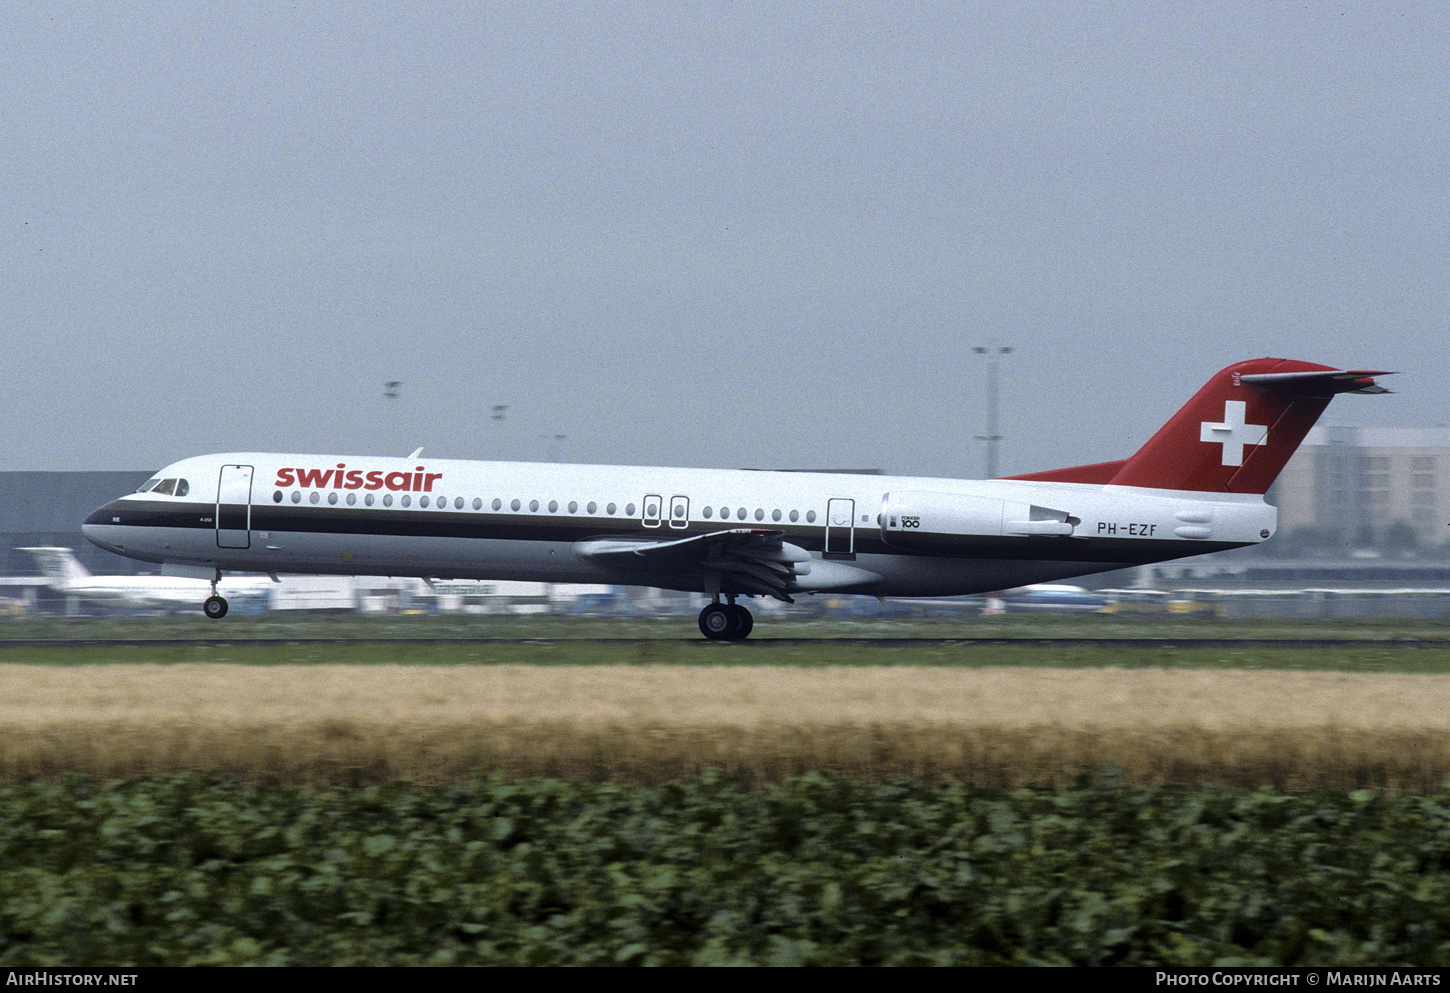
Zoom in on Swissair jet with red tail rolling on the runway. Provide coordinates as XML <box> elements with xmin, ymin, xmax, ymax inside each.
<box><xmin>83</xmin><ymin>358</ymin><xmax>1389</xmax><ymax>641</ymax></box>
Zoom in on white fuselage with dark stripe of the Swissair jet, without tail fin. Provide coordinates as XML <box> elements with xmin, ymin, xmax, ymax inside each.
<box><xmin>84</xmin><ymin>452</ymin><xmax>1276</xmax><ymax>596</ymax></box>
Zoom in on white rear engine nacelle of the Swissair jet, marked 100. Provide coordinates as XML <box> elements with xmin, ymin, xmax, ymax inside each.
<box><xmin>882</xmin><ymin>490</ymin><xmax>1080</xmax><ymax>554</ymax></box>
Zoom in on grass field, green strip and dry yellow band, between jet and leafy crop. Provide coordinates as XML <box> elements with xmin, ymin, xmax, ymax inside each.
<box><xmin>8</xmin><ymin>618</ymin><xmax>1450</xmax><ymax>790</ymax></box>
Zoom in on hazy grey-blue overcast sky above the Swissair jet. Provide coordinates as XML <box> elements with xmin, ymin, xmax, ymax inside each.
<box><xmin>0</xmin><ymin>0</ymin><xmax>1450</xmax><ymax>477</ymax></box>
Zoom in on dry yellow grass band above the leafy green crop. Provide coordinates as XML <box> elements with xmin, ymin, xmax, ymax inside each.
<box><xmin>0</xmin><ymin>664</ymin><xmax>1450</xmax><ymax>790</ymax></box>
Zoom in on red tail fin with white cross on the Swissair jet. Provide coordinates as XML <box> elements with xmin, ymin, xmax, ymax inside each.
<box><xmin>1012</xmin><ymin>358</ymin><xmax>1388</xmax><ymax>493</ymax></box>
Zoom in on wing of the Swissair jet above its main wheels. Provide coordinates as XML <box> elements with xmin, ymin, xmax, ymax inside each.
<box><xmin>574</xmin><ymin>528</ymin><xmax>811</xmax><ymax>603</ymax></box>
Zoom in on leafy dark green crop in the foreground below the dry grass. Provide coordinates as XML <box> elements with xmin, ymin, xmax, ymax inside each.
<box><xmin>0</xmin><ymin>774</ymin><xmax>1450</xmax><ymax>967</ymax></box>
